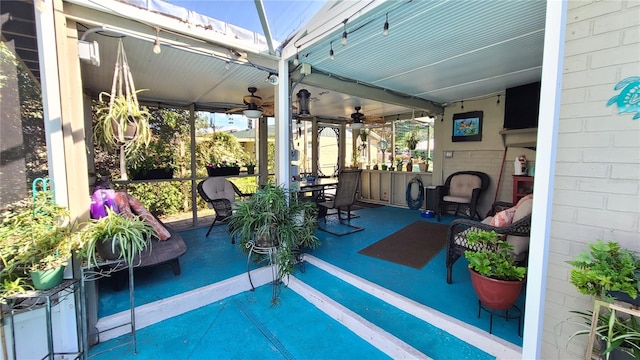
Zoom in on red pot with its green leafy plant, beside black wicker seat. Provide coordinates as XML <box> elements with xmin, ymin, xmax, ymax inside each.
<box><xmin>464</xmin><ymin>231</ymin><xmax>527</xmax><ymax>310</ymax></box>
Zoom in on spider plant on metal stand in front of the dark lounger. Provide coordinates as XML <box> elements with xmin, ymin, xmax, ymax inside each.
<box><xmin>78</xmin><ymin>207</ymin><xmax>158</xmax><ymax>267</ymax></box>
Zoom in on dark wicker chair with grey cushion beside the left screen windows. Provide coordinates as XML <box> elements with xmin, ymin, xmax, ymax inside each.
<box><xmin>198</xmin><ymin>177</ymin><xmax>253</xmax><ymax>239</ymax></box>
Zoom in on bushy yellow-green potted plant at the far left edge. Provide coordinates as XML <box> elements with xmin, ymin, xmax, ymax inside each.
<box><xmin>0</xmin><ymin>191</ymin><xmax>75</xmax><ymax>298</ymax></box>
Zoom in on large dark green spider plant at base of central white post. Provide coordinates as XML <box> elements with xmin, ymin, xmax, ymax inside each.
<box><xmin>229</xmin><ymin>184</ymin><xmax>320</xmax><ymax>279</ymax></box>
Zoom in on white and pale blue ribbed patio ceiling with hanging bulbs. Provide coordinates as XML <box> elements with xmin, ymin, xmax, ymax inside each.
<box><xmin>2</xmin><ymin>0</ymin><xmax>546</xmax><ymax>119</ymax></box>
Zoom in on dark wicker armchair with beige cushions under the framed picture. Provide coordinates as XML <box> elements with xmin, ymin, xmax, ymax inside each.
<box><xmin>436</xmin><ymin>171</ymin><xmax>489</xmax><ymax>221</ymax></box>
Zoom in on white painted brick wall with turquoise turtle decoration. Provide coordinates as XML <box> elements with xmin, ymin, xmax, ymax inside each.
<box><xmin>542</xmin><ymin>1</ymin><xmax>640</xmax><ymax>359</ymax></box>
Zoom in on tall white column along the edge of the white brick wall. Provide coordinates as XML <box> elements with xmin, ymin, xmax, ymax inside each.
<box><xmin>522</xmin><ymin>1</ymin><xmax>567</xmax><ymax>359</ymax></box>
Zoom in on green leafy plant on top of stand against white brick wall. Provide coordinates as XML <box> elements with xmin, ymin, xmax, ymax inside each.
<box><xmin>567</xmin><ymin>240</ymin><xmax>640</xmax><ymax>301</ymax></box>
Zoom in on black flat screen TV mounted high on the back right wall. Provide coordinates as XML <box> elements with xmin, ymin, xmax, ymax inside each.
<box><xmin>504</xmin><ymin>82</ymin><xmax>540</xmax><ymax>129</ymax></box>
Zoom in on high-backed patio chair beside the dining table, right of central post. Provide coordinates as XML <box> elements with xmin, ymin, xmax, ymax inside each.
<box><xmin>318</xmin><ymin>169</ymin><xmax>364</xmax><ymax>236</ymax></box>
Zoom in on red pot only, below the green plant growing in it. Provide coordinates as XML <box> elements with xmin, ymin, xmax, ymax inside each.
<box><xmin>469</xmin><ymin>269</ymin><xmax>524</xmax><ymax>310</ymax></box>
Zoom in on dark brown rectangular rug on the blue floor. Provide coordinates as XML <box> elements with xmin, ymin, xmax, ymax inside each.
<box><xmin>358</xmin><ymin>220</ymin><xmax>449</xmax><ymax>269</ymax></box>
